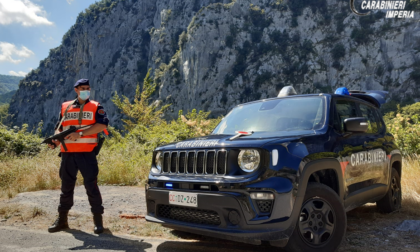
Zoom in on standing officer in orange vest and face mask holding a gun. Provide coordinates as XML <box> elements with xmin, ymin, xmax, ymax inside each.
<box><xmin>48</xmin><ymin>79</ymin><xmax>109</xmax><ymax>234</ymax></box>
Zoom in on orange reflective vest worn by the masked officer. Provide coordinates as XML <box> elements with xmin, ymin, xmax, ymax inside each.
<box><xmin>61</xmin><ymin>100</ymin><xmax>99</xmax><ymax>152</ymax></box>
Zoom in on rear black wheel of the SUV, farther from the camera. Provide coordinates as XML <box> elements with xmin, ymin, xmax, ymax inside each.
<box><xmin>376</xmin><ymin>168</ymin><xmax>402</xmax><ymax>213</ymax></box>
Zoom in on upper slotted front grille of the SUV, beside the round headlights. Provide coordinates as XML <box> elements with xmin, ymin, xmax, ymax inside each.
<box><xmin>162</xmin><ymin>150</ymin><xmax>227</xmax><ymax>175</ymax></box>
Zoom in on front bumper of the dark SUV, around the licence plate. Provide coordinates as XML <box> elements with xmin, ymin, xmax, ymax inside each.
<box><xmin>146</xmin><ymin>188</ymin><xmax>297</xmax><ymax>247</ymax></box>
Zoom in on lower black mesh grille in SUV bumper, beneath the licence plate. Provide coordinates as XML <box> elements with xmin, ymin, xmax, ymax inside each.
<box><xmin>157</xmin><ymin>205</ymin><xmax>221</xmax><ymax>226</ymax></box>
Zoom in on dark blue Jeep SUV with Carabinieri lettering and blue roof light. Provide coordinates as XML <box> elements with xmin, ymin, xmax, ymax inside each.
<box><xmin>146</xmin><ymin>87</ymin><xmax>402</xmax><ymax>252</ymax></box>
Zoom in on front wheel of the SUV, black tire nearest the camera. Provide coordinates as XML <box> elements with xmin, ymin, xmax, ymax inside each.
<box><xmin>285</xmin><ymin>183</ymin><xmax>347</xmax><ymax>252</ymax></box>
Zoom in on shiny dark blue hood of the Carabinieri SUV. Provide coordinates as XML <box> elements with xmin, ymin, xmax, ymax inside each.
<box><xmin>156</xmin><ymin>130</ymin><xmax>317</xmax><ymax>151</ymax></box>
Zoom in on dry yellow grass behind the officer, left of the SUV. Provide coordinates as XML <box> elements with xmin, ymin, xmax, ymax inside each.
<box><xmin>0</xmin><ymin>144</ymin><xmax>151</xmax><ymax>199</ymax></box>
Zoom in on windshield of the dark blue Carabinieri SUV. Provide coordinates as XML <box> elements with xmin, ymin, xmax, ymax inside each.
<box><xmin>212</xmin><ymin>97</ymin><xmax>325</xmax><ymax>135</ymax></box>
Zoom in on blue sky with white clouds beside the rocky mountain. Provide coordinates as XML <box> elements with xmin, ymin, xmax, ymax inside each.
<box><xmin>0</xmin><ymin>0</ymin><xmax>98</xmax><ymax>76</ymax></box>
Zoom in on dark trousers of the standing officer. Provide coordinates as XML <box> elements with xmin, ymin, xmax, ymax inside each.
<box><xmin>58</xmin><ymin>152</ymin><xmax>104</xmax><ymax>214</ymax></box>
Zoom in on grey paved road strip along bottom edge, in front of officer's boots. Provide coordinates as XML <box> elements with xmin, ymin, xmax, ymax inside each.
<box><xmin>0</xmin><ymin>227</ymin><xmax>279</xmax><ymax>252</ymax></box>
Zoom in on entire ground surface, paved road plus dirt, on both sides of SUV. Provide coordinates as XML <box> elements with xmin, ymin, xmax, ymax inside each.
<box><xmin>0</xmin><ymin>186</ymin><xmax>420</xmax><ymax>252</ymax></box>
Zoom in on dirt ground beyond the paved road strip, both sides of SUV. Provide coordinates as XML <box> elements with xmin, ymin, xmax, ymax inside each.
<box><xmin>0</xmin><ymin>186</ymin><xmax>420</xmax><ymax>252</ymax></box>
